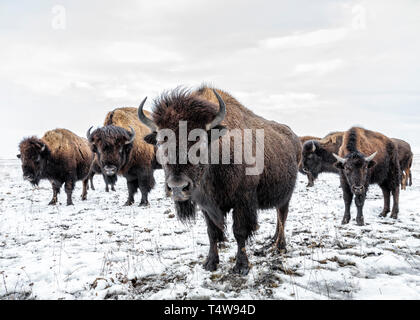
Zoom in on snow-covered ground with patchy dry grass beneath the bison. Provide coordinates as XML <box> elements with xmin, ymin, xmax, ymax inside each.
<box><xmin>0</xmin><ymin>156</ymin><xmax>420</xmax><ymax>299</ymax></box>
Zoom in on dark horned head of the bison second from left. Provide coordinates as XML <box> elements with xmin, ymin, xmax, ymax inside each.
<box><xmin>87</xmin><ymin>125</ymin><xmax>136</xmax><ymax>180</ymax></box>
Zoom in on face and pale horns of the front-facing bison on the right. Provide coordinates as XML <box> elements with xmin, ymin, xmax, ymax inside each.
<box><xmin>334</xmin><ymin>152</ymin><xmax>376</xmax><ymax>195</ymax></box>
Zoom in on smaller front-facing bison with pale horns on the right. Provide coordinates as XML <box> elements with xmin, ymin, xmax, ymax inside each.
<box><xmin>334</xmin><ymin>127</ymin><xmax>400</xmax><ymax>226</ymax></box>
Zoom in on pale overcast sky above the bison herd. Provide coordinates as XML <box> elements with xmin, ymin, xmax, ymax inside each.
<box><xmin>0</xmin><ymin>0</ymin><xmax>420</xmax><ymax>158</ymax></box>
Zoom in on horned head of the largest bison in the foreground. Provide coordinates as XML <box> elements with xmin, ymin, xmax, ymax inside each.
<box><xmin>138</xmin><ymin>90</ymin><xmax>226</xmax><ymax>204</ymax></box>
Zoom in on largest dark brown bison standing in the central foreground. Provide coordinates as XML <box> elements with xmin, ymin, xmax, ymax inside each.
<box><xmin>139</xmin><ymin>86</ymin><xmax>301</xmax><ymax>275</ymax></box>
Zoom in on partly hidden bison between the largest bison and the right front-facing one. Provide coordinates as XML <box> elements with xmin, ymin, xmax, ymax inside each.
<box><xmin>301</xmin><ymin>132</ymin><xmax>344</xmax><ymax>185</ymax></box>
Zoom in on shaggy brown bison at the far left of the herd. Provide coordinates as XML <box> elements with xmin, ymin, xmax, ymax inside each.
<box><xmin>18</xmin><ymin>129</ymin><xmax>93</xmax><ymax>205</ymax></box>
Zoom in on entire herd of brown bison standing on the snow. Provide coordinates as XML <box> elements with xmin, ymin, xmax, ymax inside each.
<box><xmin>18</xmin><ymin>86</ymin><xmax>413</xmax><ymax>275</ymax></box>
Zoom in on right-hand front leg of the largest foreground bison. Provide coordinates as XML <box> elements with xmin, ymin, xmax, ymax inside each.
<box><xmin>232</xmin><ymin>208</ymin><xmax>257</xmax><ymax>276</ymax></box>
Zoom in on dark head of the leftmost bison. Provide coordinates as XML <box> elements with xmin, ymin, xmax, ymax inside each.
<box><xmin>17</xmin><ymin>137</ymin><xmax>50</xmax><ymax>185</ymax></box>
